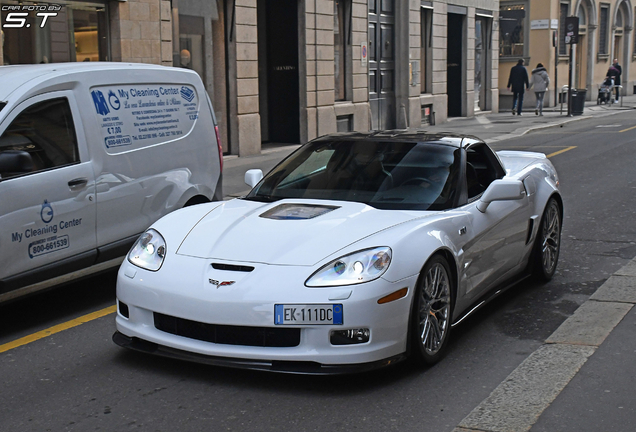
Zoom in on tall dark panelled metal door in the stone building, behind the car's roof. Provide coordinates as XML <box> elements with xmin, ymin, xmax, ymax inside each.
<box><xmin>368</xmin><ymin>0</ymin><xmax>395</xmax><ymax>130</ymax></box>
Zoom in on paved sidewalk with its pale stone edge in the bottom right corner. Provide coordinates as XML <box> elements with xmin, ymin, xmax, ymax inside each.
<box><xmin>453</xmin><ymin>258</ymin><xmax>636</xmax><ymax>432</ymax></box>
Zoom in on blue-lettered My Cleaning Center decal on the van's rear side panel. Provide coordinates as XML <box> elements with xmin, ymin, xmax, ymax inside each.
<box><xmin>91</xmin><ymin>84</ymin><xmax>199</xmax><ymax>153</ymax></box>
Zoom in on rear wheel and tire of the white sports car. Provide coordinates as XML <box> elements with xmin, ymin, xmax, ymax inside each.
<box><xmin>533</xmin><ymin>198</ymin><xmax>563</xmax><ymax>282</ymax></box>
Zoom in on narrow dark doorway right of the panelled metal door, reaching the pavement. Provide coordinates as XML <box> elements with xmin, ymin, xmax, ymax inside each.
<box><xmin>446</xmin><ymin>13</ymin><xmax>464</xmax><ymax>117</ymax></box>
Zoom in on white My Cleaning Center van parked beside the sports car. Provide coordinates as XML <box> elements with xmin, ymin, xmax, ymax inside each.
<box><xmin>0</xmin><ymin>62</ymin><xmax>223</xmax><ymax>301</ymax></box>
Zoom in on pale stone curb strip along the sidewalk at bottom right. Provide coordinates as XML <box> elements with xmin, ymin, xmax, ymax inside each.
<box><xmin>453</xmin><ymin>258</ymin><xmax>636</xmax><ymax>432</ymax></box>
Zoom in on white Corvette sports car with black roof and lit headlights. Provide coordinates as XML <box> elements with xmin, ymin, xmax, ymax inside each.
<box><xmin>113</xmin><ymin>131</ymin><xmax>563</xmax><ymax>374</ymax></box>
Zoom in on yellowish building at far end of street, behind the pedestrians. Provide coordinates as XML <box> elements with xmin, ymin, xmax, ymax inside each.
<box><xmin>499</xmin><ymin>0</ymin><xmax>636</xmax><ymax>109</ymax></box>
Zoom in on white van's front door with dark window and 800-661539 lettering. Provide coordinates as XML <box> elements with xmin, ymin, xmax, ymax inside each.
<box><xmin>0</xmin><ymin>91</ymin><xmax>96</xmax><ymax>286</ymax></box>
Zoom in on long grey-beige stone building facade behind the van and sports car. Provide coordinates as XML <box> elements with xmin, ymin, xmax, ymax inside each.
<box><xmin>0</xmin><ymin>0</ymin><xmax>500</xmax><ymax>156</ymax></box>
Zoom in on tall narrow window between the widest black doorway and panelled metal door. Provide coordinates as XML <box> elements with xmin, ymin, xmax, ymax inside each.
<box><xmin>333</xmin><ymin>0</ymin><xmax>351</xmax><ymax>101</ymax></box>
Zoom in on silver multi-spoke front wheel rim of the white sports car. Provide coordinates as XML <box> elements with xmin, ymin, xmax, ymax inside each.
<box><xmin>419</xmin><ymin>262</ymin><xmax>451</xmax><ymax>356</ymax></box>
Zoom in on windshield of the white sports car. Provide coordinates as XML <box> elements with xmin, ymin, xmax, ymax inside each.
<box><xmin>246</xmin><ymin>140</ymin><xmax>460</xmax><ymax>210</ymax></box>
